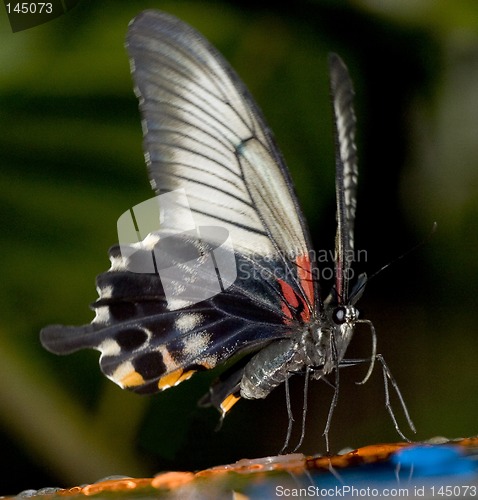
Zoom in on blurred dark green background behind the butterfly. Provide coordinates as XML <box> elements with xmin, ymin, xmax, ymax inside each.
<box><xmin>0</xmin><ymin>0</ymin><xmax>478</xmax><ymax>494</ymax></box>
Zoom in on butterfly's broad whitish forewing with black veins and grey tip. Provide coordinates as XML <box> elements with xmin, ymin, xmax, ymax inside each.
<box><xmin>127</xmin><ymin>11</ymin><xmax>309</xmax><ymax>259</ymax></box>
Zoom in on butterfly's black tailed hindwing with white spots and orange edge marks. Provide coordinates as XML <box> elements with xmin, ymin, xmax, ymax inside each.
<box><xmin>41</xmin><ymin>238</ymin><xmax>310</xmax><ymax>393</ymax></box>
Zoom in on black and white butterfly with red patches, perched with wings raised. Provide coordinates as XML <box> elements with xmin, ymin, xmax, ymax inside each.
<box><xmin>40</xmin><ymin>10</ymin><xmax>413</xmax><ymax>450</ymax></box>
